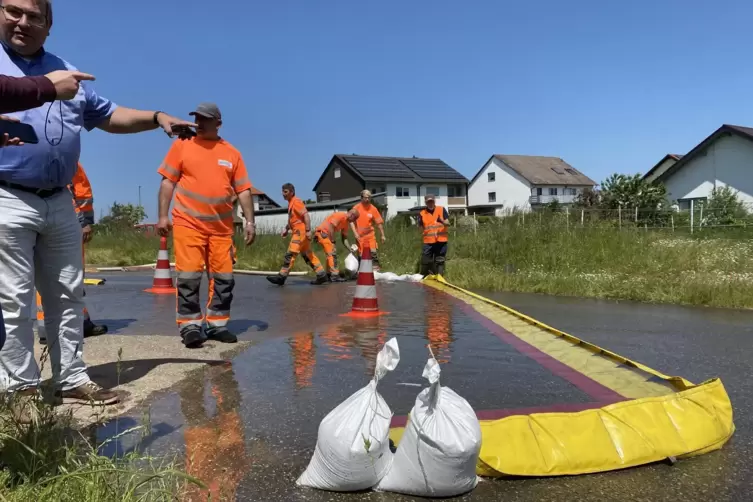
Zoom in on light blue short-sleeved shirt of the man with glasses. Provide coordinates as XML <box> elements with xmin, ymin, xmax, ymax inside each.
<box><xmin>0</xmin><ymin>42</ymin><xmax>117</xmax><ymax>188</ymax></box>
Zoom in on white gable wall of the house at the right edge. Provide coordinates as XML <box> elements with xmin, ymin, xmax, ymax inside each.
<box><xmin>662</xmin><ymin>136</ymin><xmax>753</xmax><ymax>208</ymax></box>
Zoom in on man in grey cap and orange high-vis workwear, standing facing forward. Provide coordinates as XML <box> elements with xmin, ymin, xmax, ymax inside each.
<box><xmin>157</xmin><ymin>103</ymin><xmax>256</xmax><ymax>348</ymax></box>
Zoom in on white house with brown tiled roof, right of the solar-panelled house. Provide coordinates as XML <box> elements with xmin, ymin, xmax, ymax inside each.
<box><xmin>468</xmin><ymin>155</ymin><xmax>596</xmax><ymax>216</ymax></box>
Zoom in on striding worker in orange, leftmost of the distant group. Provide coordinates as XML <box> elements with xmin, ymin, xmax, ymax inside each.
<box><xmin>267</xmin><ymin>183</ymin><xmax>327</xmax><ymax>286</ymax></box>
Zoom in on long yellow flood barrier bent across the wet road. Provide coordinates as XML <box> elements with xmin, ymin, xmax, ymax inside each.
<box><xmin>390</xmin><ymin>276</ymin><xmax>735</xmax><ymax>477</ymax></box>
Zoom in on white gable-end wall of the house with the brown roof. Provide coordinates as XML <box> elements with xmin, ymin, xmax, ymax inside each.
<box><xmin>468</xmin><ymin>158</ymin><xmax>531</xmax><ymax>209</ymax></box>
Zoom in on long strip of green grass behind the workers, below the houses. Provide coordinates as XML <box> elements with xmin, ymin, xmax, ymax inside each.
<box><xmin>87</xmin><ymin>217</ymin><xmax>753</xmax><ymax>308</ymax></box>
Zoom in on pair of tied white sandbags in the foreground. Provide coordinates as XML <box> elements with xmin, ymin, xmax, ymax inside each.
<box><xmin>297</xmin><ymin>344</ymin><xmax>481</xmax><ymax>497</ymax></box>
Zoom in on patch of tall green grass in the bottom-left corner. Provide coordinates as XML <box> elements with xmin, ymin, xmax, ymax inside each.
<box><xmin>0</xmin><ymin>352</ymin><xmax>204</xmax><ymax>502</ymax></box>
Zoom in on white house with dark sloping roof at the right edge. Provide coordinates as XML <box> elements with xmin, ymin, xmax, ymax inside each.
<box><xmin>644</xmin><ymin>124</ymin><xmax>753</xmax><ymax>209</ymax></box>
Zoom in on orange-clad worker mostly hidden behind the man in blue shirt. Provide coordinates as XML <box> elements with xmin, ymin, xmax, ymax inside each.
<box><xmin>37</xmin><ymin>162</ymin><xmax>107</xmax><ymax>345</ymax></box>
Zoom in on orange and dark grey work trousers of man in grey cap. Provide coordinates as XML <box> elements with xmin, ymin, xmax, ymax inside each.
<box><xmin>173</xmin><ymin>225</ymin><xmax>235</xmax><ymax>331</ymax></box>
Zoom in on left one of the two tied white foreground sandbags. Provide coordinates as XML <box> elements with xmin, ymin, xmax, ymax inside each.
<box><xmin>296</xmin><ymin>338</ymin><xmax>400</xmax><ymax>492</ymax></box>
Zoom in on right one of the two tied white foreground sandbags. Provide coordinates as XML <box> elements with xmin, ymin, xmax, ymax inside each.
<box><xmin>376</xmin><ymin>356</ymin><xmax>481</xmax><ymax>497</ymax></box>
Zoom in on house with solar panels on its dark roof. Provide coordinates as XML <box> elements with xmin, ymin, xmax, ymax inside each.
<box><xmin>314</xmin><ymin>154</ymin><xmax>468</xmax><ymax>219</ymax></box>
